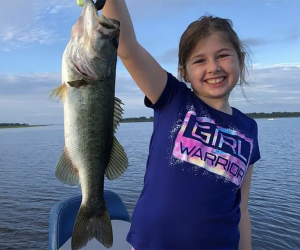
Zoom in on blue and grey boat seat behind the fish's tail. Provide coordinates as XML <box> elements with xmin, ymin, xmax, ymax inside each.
<box><xmin>49</xmin><ymin>190</ymin><xmax>131</xmax><ymax>250</ymax></box>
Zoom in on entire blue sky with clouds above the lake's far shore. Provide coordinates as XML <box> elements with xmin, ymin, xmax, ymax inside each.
<box><xmin>0</xmin><ymin>0</ymin><xmax>300</xmax><ymax>124</ymax></box>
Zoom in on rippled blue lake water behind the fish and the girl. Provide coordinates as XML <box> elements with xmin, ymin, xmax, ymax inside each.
<box><xmin>0</xmin><ymin>118</ymin><xmax>300</xmax><ymax>250</ymax></box>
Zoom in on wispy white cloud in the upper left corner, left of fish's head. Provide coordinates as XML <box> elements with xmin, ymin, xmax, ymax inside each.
<box><xmin>0</xmin><ymin>0</ymin><xmax>79</xmax><ymax>51</ymax></box>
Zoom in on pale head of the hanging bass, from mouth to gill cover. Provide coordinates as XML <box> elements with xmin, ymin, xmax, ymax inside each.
<box><xmin>67</xmin><ymin>0</ymin><xmax>120</xmax><ymax>81</ymax></box>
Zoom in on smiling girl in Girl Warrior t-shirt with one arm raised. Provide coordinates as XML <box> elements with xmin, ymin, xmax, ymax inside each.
<box><xmin>103</xmin><ymin>0</ymin><xmax>260</xmax><ymax>250</ymax></box>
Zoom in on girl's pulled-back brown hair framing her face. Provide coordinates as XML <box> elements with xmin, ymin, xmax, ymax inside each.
<box><xmin>178</xmin><ymin>15</ymin><xmax>251</xmax><ymax>93</ymax></box>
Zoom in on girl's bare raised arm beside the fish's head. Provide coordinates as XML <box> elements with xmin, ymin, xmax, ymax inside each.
<box><xmin>102</xmin><ymin>0</ymin><xmax>167</xmax><ymax>104</ymax></box>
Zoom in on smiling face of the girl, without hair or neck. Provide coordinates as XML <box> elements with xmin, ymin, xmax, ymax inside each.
<box><xmin>181</xmin><ymin>33</ymin><xmax>240</xmax><ymax>100</ymax></box>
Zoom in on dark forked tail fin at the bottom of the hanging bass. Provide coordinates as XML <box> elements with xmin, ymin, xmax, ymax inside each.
<box><xmin>71</xmin><ymin>205</ymin><xmax>113</xmax><ymax>250</ymax></box>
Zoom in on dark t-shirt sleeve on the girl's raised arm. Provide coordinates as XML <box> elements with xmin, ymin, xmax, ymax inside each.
<box><xmin>144</xmin><ymin>72</ymin><xmax>187</xmax><ymax>110</ymax></box>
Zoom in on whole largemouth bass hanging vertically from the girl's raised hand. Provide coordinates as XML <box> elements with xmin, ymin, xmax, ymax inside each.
<box><xmin>50</xmin><ymin>0</ymin><xmax>128</xmax><ymax>250</ymax></box>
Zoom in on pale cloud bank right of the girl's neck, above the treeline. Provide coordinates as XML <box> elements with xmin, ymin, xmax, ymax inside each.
<box><xmin>227</xmin><ymin>63</ymin><xmax>300</xmax><ymax>112</ymax></box>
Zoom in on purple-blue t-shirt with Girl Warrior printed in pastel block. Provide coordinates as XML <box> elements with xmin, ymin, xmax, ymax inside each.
<box><xmin>127</xmin><ymin>73</ymin><xmax>260</xmax><ymax>250</ymax></box>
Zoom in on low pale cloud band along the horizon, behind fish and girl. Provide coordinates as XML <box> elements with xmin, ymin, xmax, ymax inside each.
<box><xmin>0</xmin><ymin>64</ymin><xmax>300</xmax><ymax>124</ymax></box>
